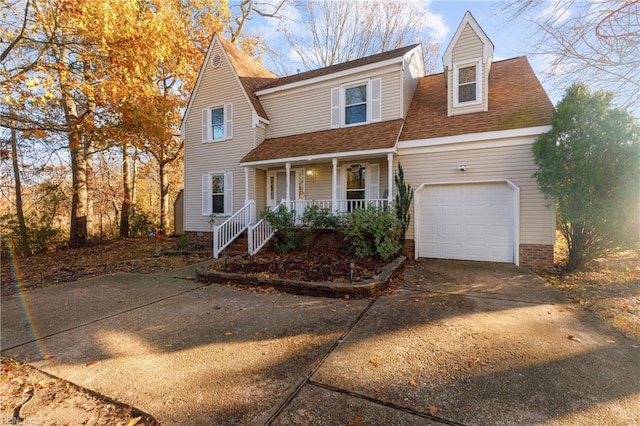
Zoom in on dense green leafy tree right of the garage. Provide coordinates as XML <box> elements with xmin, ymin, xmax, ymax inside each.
<box><xmin>533</xmin><ymin>84</ymin><xmax>640</xmax><ymax>271</ymax></box>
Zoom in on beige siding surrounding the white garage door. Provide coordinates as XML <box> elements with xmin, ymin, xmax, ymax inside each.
<box><xmin>398</xmin><ymin>141</ymin><xmax>555</xmax><ymax>244</ymax></box>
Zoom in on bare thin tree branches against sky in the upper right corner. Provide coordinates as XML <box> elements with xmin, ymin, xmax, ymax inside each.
<box><xmin>505</xmin><ymin>0</ymin><xmax>640</xmax><ymax>116</ymax></box>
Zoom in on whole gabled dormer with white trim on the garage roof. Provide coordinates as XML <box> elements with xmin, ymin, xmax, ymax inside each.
<box><xmin>442</xmin><ymin>12</ymin><xmax>494</xmax><ymax>116</ymax></box>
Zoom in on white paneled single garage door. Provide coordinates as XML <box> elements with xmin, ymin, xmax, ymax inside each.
<box><xmin>417</xmin><ymin>183</ymin><xmax>515</xmax><ymax>263</ymax></box>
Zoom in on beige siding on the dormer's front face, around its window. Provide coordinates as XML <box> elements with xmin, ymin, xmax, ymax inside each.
<box><xmin>447</xmin><ymin>24</ymin><xmax>489</xmax><ymax>115</ymax></box>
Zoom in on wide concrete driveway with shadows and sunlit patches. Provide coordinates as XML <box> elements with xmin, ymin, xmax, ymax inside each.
<box><xmin>1</xmin><ymin>260</ymin><xmax>640</xmax><ymax>425</ymax></box>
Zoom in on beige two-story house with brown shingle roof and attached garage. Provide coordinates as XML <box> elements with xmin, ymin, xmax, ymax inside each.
<box><xmin>182</xmin><ymin>12</ymin><xmax>555</xmax><ymax>270</ymax></box>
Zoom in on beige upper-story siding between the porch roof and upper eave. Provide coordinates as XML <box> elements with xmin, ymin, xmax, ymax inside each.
<box><xmin>260</xmin><ymin>64</ymin><xmax>402</xmax><ymax>138</ymax></box>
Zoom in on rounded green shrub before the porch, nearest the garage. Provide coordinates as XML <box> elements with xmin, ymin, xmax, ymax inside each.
<box><xmin>342</xmin><ymin>208</ymin><xmax>401</xmax><ymax>259</ymax></box>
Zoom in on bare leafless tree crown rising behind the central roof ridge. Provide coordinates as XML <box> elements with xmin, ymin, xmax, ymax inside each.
<box><xmin>272</xmin><ymin>0</ymin><xmax>438</xmax><ymax>70</ymax></box>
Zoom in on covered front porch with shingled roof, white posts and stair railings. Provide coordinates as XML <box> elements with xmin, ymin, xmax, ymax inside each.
<box><xmin>213</xmin><ymin>120</ymin><xmax>403</xmax><ymax>257</ymax></box>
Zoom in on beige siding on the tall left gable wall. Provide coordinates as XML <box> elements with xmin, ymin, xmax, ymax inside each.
<box><xmin>184</xmin><ymin>40</ymin><xmax>256</xmax><ymax>231</ymax></box>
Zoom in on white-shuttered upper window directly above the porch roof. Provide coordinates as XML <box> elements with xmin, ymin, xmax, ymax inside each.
<box><xmin>331</xmin><ymin>78</ymin><xmax>382</xmax><ymax>128</ymax></box>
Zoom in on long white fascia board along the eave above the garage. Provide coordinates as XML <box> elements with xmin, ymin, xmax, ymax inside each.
<box><xmin>398</xmin><ymin>126</ymin><xmax>551</xmax><ymax>152</ymax></box>
